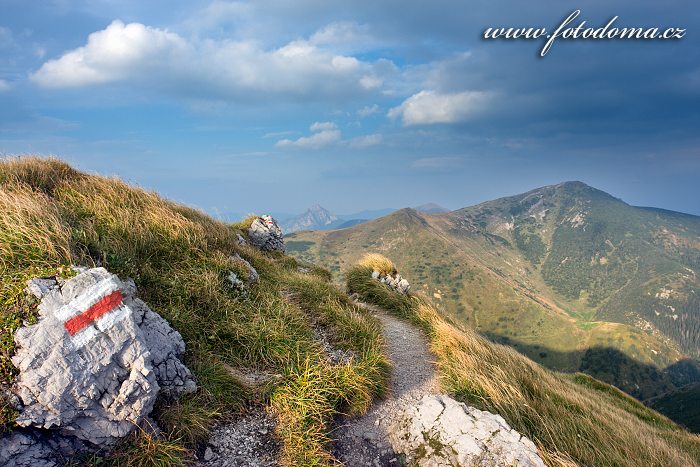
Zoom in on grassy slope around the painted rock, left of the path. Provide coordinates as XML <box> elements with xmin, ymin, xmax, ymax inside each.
<box><xmin>0</xmin><ymin>158</ymin><xmax>387</xmax><ymax>465</ymax></box>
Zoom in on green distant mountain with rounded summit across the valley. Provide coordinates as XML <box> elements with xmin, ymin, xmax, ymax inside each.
<box><xmin>287</xmin><ymin>182</ymin><xmax>700</xmax><ymax>406</ymax></box>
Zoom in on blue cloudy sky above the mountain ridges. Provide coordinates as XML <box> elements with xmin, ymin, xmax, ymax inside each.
<box><xmin>0</xmin><ymin>0</ymin><xmax>700</xmax><ymax>218</ymax></box>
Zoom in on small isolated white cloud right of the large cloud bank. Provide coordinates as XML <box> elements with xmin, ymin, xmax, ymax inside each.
<box><xmin>388</xmin><ymin>91</ymin><xmax>491</xmax><ymax>126</ymax></box>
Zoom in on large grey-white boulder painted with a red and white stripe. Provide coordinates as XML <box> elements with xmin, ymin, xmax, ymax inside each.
<box><xmin>12</xmin><ymin>268</ymin><xmax>196</xmax><ymax>446</ymax></box>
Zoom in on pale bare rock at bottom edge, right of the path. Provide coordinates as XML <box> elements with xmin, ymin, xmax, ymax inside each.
<box><xmin>389</xmin><ymin>395</ymin><xmax>545</xmax><ymax>467</ymax></box>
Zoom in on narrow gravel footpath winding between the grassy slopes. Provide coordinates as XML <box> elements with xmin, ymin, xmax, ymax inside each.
<box><xmin>333</xmin><ymin>304</ymin><xmax>438</xmax><ymax>467</ymax></box>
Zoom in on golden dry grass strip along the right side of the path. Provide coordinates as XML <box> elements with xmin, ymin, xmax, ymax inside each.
<box><xmin>346</xmin><ymin>256</ymin><xmax>700</xmax><ymax>466</ymax></box>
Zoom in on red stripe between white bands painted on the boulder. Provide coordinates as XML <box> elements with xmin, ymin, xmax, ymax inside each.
<box><xmin>55</xmin><ymin>280</ymin><xmax>131</xmax><ymax>348</ymax></box>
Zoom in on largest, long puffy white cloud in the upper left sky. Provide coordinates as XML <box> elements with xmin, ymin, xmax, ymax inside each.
<box><xmin>31</xmin><ymin>21</ymin><xmax>392</xmax><ymax>99</ymax></box>
